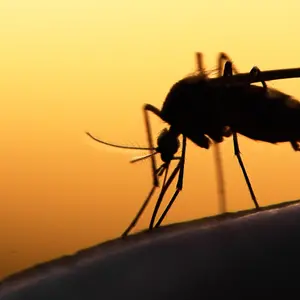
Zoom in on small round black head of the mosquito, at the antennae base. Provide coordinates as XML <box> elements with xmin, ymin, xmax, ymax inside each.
<box><xmin>157</xmin><ymin>128</ymin><xmax>180</xmax><ymax>162</ymax></box>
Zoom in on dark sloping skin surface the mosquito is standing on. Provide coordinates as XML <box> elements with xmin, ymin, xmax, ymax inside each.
<box><xmin>0</xmin><ymin>201</ymin><xmax>300</xmax><ymax>300</ymax></box>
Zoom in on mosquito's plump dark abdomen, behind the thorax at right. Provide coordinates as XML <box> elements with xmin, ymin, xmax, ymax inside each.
<box><xmin>230</xmin><ymin>86</ymin><xmax>300</xmax><ymax>143</ymax></box>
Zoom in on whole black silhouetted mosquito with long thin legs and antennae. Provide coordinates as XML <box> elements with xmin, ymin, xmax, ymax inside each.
<box><xmin>87</xmin><ymin>52</ymin><xmax>300</xmax><ymax>237</ymax></box>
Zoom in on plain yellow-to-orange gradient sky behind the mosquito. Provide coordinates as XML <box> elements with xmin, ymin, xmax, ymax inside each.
<box><xmin>0</xmin><ymin>0</ymin><xmax>300</xmax><ymax>278</ymax></box>
